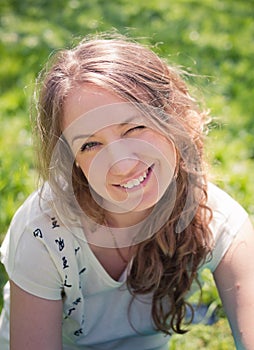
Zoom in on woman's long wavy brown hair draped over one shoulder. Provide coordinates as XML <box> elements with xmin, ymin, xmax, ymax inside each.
<box><xmin>32</xmin><ymin>35</ymin><xmax>212</xmax><ymax>334</ymax></box>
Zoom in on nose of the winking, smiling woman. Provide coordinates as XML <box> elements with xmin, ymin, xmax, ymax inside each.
<box><xmin>107</xmin><ymin>140</ymin><xmax>140</xmax><ymax>176</ymax></box>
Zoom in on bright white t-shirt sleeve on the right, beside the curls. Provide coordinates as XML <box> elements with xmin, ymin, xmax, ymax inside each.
<box><xmin>205</xmin><ymin>184</ymin><xmax>248</xmax><ymax>272</ymax></box>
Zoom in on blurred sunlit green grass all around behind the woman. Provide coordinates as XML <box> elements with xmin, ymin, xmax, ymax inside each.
<box><xmin>0</xmin><ymin>0</ymin><xmax>254</xmax><ymax>350</ymax></box>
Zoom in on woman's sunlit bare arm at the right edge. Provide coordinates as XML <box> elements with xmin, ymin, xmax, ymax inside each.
<box><xmin>214</xmin><ymin>219</ymin><xmax>254</xmax><ymax>350</ymax></box>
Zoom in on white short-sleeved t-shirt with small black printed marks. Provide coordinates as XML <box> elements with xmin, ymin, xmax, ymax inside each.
<box><xmin>0</xmin><ymin>184</ymin><xmax>247</xmax><ymax>350</ymax></box>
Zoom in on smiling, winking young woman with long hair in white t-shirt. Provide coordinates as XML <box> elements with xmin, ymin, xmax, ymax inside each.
<box><xmin>0</xmin><ymin>33</ymin><xmax>254</xmax><ymax>350</ymax></box>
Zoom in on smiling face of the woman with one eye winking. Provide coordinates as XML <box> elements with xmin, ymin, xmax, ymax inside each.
<box><xmin>63</xmin><ymin>85</ymin><xmax>176</xmax><ymax>213</ymax></box>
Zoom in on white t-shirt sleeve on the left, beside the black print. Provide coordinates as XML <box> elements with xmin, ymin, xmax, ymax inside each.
<box><xmin>0</xmin><ymin>208</ymin><xmax>63</xmax><ymax>300</ymax></box>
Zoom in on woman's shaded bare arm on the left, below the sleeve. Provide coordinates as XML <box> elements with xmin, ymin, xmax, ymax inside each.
<box><xmin>10</xmin><ymin>281</ymin><xmax>62</xmax><ymax>350</ymax></box>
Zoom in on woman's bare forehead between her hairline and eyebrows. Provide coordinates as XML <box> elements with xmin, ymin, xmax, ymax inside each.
<box><xmin>62</xmin><ymin>86</ymin><xmax>149</xmax><ymax>140</ymax></box>
